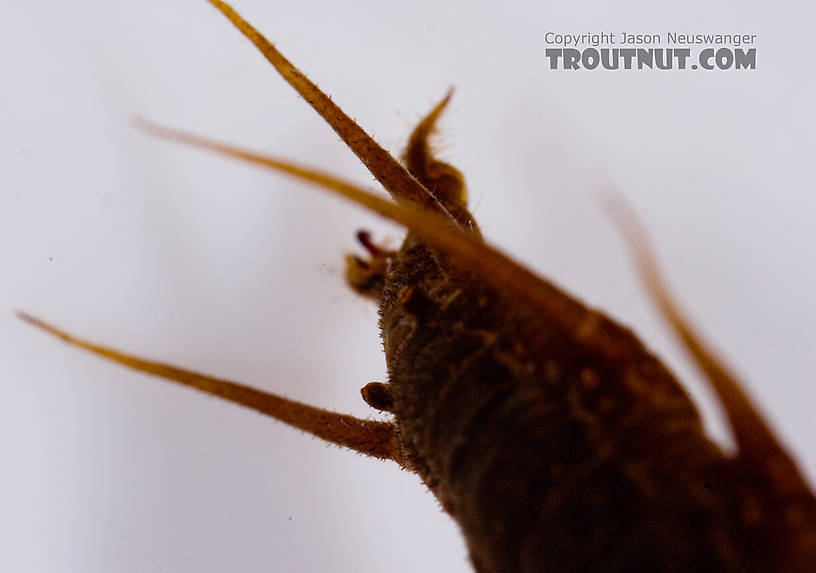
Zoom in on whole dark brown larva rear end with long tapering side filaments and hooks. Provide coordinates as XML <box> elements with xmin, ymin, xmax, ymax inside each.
<box><xmin>20</xmin><ymin>0</ymin><xmax>816</xmax><ymax>573</ymax></box>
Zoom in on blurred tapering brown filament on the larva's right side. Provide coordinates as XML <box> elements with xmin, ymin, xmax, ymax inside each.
<box><xmin>609</xmin><ymin>199</ymin><xmax>798</xmax><ymax>474</ymax></box>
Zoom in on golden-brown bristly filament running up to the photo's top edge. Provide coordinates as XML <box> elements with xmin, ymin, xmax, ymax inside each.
<box><xmin>199</xmin><ymin>0</ymin><xmax>460</xmax><ymax>223</ymax></box>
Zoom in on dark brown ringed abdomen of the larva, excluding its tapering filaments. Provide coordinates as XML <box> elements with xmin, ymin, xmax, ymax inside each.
<box><xmin>381</xmin><ymin>240</ymin><xmax>745</xmax><ymax>572</ymax></box>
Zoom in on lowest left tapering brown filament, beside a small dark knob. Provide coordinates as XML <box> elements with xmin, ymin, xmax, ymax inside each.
<box><xmin>17</xmin><ymin>312</ymin><xmax>404</xmax><ymax>466</ymax></box>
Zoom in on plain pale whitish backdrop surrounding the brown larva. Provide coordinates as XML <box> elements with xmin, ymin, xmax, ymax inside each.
<box><xmin>0</xmin><ymin>0</ymin><xmax>816</xmax><ymax>572</ymax></box>
